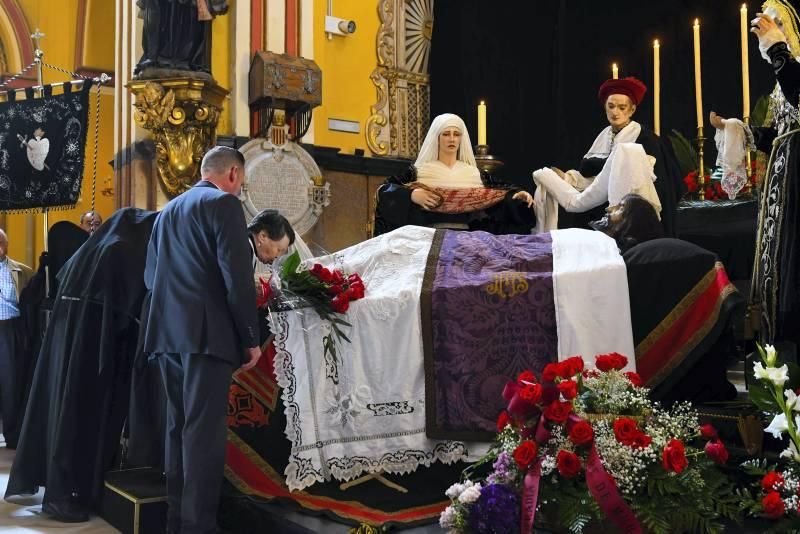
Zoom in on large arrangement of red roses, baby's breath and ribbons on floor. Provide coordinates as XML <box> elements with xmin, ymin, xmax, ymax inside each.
<box><xmin>440</xmin><ymin>353</ymin><xmax>739</xmax><ymax>533</ymax></box>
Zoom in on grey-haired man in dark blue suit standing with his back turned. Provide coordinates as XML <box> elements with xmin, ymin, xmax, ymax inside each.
<box><xmin>144</xmin><ymin>147</ymin><xmax>261</xmax><ymax>534</ymax></box>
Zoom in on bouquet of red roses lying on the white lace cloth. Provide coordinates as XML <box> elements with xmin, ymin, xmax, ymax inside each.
<box><xmin>280</xmin><ymin>251</ymin><xmax>366</xmax><ymax>369</ymax></box>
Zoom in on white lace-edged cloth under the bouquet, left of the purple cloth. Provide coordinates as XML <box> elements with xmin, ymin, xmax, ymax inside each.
<box><xmin>272</xmin><ymin>226</ymin><xmax>468</xmax><ymax>491</ymax></box>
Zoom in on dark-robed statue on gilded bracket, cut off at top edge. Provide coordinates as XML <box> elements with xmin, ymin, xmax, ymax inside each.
<box><xmin>135</xmin><ymin>0</ymin><xmax>228</xmax><ymax>80</ymax></box>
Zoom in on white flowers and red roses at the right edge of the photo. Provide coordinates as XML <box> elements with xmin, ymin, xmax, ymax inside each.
<box><xmin>742</xmin><ymin>345</ymin><xmax>800</xmax><ymax>532</ymax></box>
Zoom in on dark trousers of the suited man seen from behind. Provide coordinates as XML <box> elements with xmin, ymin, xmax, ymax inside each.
<box><xmin>157</xmin><ymin>354</ymin><xmax>233</xmax><ymax>534</ymax></box>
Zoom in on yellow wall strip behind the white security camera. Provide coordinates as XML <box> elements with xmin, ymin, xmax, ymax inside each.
<box><xmin>314</xmin><ymin>0</ymin><xmax>380</xmax><ymax>154</ymax></box>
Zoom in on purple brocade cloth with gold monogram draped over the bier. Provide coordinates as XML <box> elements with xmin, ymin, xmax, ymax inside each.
<box><xmin>421</xmin><ymin>230</ymin><xmax>557</xmax><ymax>441</ymax></box>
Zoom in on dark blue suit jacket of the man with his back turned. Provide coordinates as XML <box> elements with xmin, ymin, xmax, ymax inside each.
<box><xmin>144</xmin><ymin>181</ymin><xmax>258</xmax><ymax>366</ymax></box>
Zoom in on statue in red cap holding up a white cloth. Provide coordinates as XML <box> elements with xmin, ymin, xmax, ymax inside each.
<box><xmin>533</xmin><ymin>78</ymin><xmax>682</xmax><ymax>236</ymax></box>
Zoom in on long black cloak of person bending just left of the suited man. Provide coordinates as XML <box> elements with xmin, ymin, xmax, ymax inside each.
<box><xmin>6</xmin><ymin>208</ymin><xmax>156</xmax><ymax>520</ymax></box>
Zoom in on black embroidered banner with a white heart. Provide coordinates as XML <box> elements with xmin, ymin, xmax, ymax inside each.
<box><xmin>0</xmin><ymin>80</ymin><xmax>91</xmax><ymax>211</ymax></box>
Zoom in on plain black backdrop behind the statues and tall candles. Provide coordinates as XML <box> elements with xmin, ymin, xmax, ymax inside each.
<box><xmin>430</xmin><ymin>0</ymin><xmax>774</xmax><ymax>184</ymax></box>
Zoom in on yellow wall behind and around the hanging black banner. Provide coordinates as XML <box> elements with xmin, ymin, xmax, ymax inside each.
<box><xmin>6</xmin><ymin>0</ymin><xmax>114</xmax><ymax>262</ymax></box>
